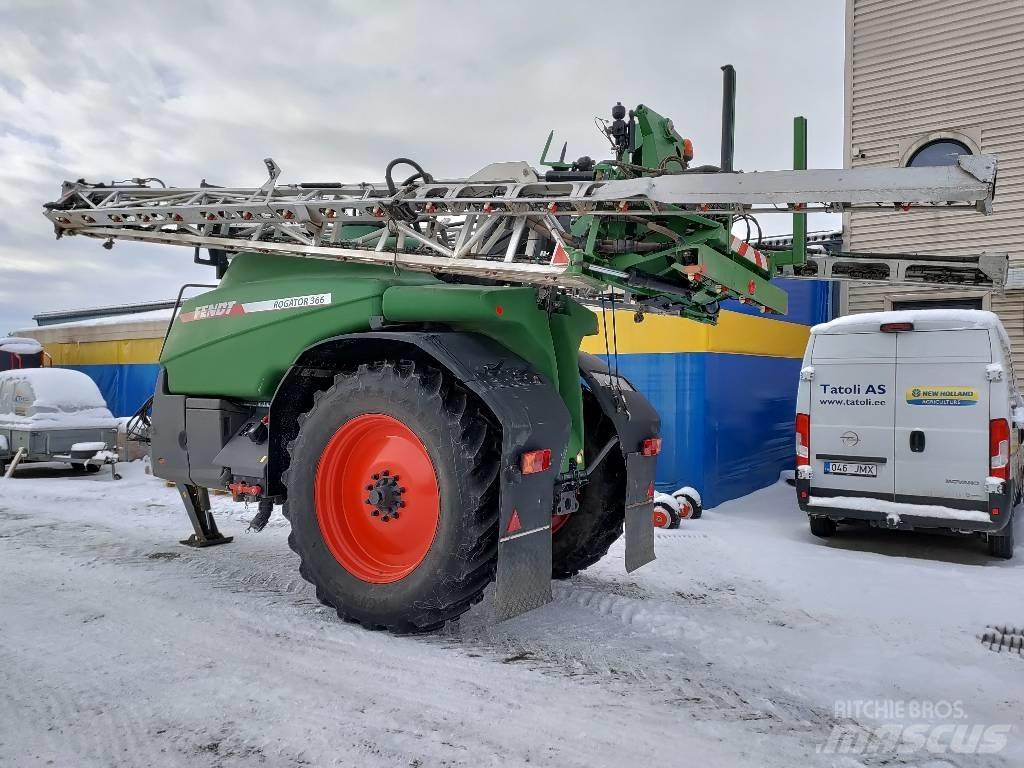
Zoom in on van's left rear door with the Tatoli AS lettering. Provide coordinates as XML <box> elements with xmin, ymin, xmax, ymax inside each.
<box><xmin>810</xmin><ymin>333</ymin><xmax>896</xmax><ymax>501</ymax></box>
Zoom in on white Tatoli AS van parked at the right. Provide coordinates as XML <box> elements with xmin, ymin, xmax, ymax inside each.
<box><xmin>796</xmin><ymin>309</ymin><xmax>1024</xmax><ymax>558</ymax></box>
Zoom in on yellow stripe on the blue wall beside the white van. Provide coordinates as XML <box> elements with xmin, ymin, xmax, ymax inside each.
<box><xmin>583</xmin><ymin>309</ymin><xmax>810</xmax><ymax>358</ymax></box>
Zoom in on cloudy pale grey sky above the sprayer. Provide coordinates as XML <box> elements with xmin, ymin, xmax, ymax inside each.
<box><xmin>0</xmin><ymin>0</ymin><xmax>844</xmax><ymax>334</ymax></box>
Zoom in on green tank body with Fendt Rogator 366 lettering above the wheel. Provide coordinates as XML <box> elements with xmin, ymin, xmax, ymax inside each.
<box><xmin>161</xmin><ymin>253</ymin><xmax>597</xmax><ymax>464</ymax></box>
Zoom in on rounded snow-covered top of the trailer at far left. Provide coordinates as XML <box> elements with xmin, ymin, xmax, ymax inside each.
<box><xmin>0</xmin><ymin>368</ymin><xmax>118</xmax><ymax>429</ymax></box>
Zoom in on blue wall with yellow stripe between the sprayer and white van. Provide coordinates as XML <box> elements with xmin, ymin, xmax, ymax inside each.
<box><xmin>587</xmin><ymin>280</ymin><xmax>831</xmax><ymax>507</ymax></box>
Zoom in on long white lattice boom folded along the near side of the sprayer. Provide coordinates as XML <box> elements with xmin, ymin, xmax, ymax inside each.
<box><xmin>45</xmin><ymin>155</ymin><xmax>996</xmax><ymax>292</ymax></box>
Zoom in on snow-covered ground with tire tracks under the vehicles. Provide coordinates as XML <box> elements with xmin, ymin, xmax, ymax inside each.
<box><xmin>0</xmin><ymin>462</ymin><xmax>1024</xmax><ymax>768</ymax></box>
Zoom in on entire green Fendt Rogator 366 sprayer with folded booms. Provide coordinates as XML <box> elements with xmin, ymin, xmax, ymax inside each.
<box><xmin>45</xmin><ymin>68</ymin><xmax>1006</xmax><ymax>632</ymax></box>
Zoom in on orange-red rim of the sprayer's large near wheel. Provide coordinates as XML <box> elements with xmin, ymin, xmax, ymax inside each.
<box><xmin>314</xmin><ymin>414</ymin><xmax>440</xmax><ymax>584</ymax></box>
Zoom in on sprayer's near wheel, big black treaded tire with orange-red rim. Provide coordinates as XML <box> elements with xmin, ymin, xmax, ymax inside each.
<box><xmin>283</xmin><ymin>360</ymin><xmax>501</xmax><ymax>633</ymax></box>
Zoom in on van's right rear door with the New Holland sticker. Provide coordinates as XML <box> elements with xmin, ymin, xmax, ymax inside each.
<box><xmin>894</xmin><ymin>330</ymin><xmax>992</xmax><ymax>507</ymax></box>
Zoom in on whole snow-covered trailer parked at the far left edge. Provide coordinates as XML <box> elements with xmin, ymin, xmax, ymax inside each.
<box><xmin>0</xmin><ymin>368</ymin><xmax>118</xmax><ymax>474</ymax></box>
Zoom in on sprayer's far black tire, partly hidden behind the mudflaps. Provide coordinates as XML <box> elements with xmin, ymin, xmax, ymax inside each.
<box><xmin>551</xmin><ymin>392</ymin><xmax>626</xmax><ymax>579</ymax></box>
